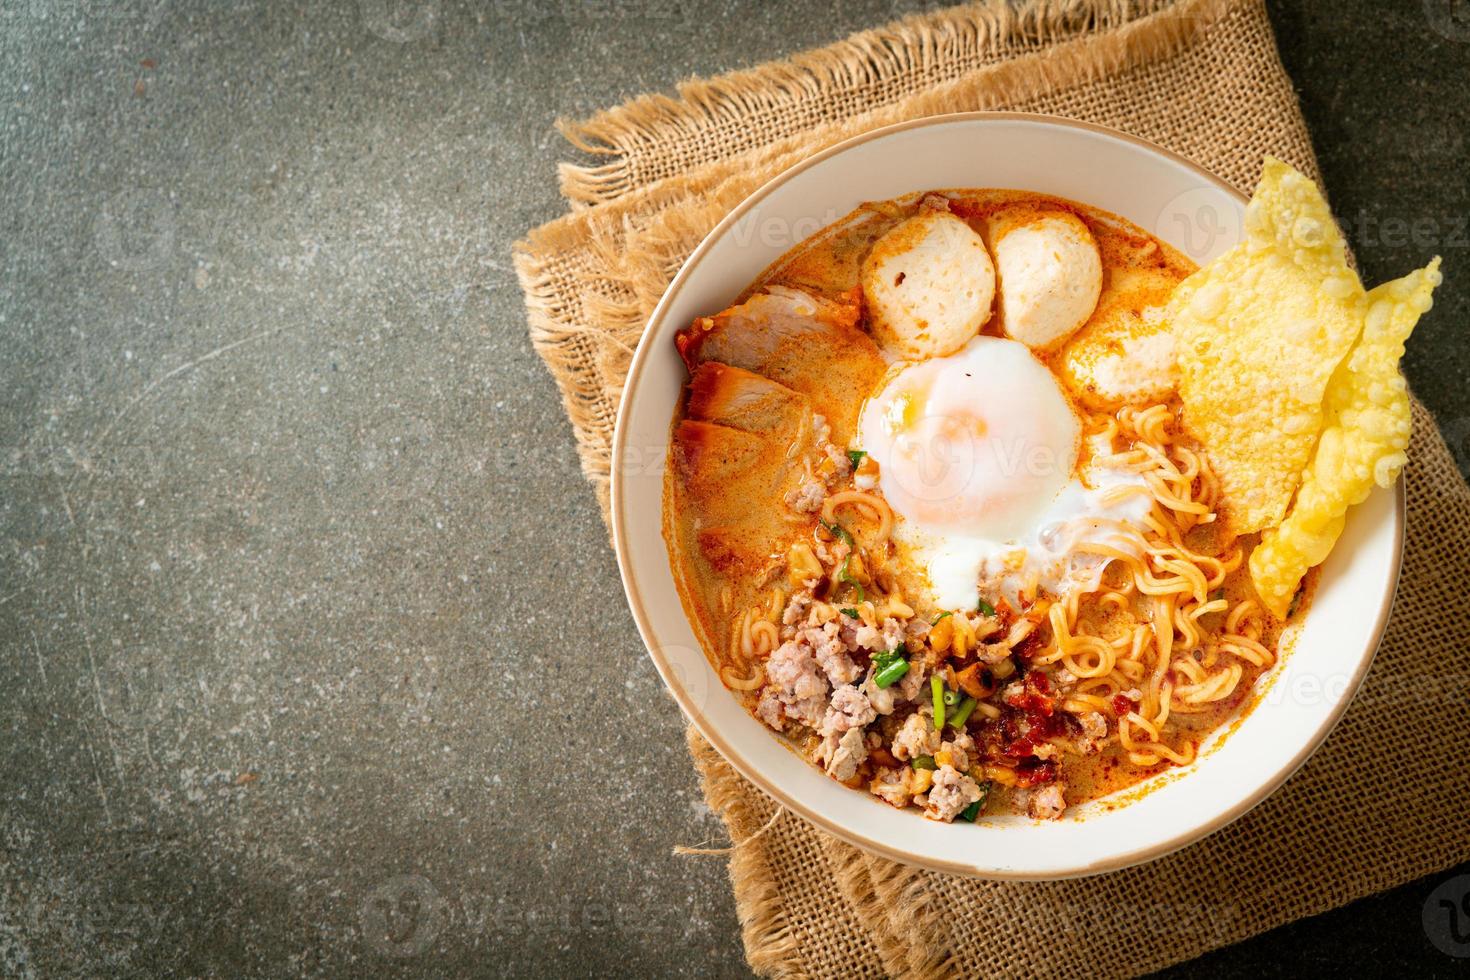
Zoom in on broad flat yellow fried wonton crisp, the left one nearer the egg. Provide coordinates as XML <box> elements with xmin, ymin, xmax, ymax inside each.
<box><xmin>1166</xmin><ymin>157</ymin><xmax>1364</xmax><ymax>533</ymax></box>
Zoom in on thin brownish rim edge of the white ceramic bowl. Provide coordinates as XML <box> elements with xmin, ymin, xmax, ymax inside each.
<box><xmin>610</xmin><ymin>112</ymin><xmax>1405</xmax><ymax>882</ymax></box>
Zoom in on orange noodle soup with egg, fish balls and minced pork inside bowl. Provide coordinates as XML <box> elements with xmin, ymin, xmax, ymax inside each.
<box><xmin>664</xmin><ymin>190</ymin><xmax>1310</xmax><ymax>821</ymax></box>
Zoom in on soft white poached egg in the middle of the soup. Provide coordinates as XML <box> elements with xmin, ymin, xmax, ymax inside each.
<box><xmin>858</xmin><ymin>336</ymin><xmax>1152</xmax><ymax>610</ymax></box>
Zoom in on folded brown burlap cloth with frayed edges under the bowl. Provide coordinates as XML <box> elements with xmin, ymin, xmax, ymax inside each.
<box><xmin>516</xmin><ymin>0</ymin><xmax>1470</xmax><ymax>976</ymax></box>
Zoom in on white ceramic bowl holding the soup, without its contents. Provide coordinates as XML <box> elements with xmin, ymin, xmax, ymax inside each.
<box><xmin>613</xmin><ymin>113</ymin><xmax>1404</xmax><ymax>879</ymax></box>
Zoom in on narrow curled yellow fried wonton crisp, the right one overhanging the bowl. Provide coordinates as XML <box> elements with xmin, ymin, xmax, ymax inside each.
<box><xmin>1251</xmin><ymin>259</ymin><xmax>1441</xmax><ymax>617</ymax></box>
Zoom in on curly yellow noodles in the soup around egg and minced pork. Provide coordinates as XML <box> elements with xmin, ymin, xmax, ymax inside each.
<box><xmin>740</xmin><ymin>404</ymin><xmax>1276</xmax><ymax>799</ymax></box>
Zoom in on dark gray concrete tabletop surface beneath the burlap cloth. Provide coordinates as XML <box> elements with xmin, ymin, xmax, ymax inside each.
<box><xmin>0</xmin><ymin>0</ymin><xmax>1470</xmax><ymax>977</ymax></box>
